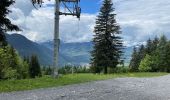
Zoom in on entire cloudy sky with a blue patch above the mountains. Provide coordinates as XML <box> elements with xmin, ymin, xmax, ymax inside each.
<box><xmin>8</xmin><ymin>0</ymin><xmax>170</xmax><ymax>46</ymax></box>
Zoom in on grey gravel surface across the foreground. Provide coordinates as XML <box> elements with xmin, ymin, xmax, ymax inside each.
<box><xmin>0</xmin><ymin>75</ymin><xmax>170</xmax><ymax>100</ymax></box>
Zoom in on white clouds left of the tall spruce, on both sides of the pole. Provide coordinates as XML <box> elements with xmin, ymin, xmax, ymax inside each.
<box><xmin>9</xmin><ymin>0</ymin><xmax>95</xmax><ymax>42</ymax></box>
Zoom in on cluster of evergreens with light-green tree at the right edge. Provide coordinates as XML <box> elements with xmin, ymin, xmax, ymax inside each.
<box><xmin>129</xmin><ymin>35</ymin><xmax>170</xmax><ymax>72</ymax></box>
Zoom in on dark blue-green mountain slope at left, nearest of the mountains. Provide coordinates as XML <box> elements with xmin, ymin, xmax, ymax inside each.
<box><xmin>6</xmin><ymin>34</ymin><xmax>52</xmax><ymax>65</ymax></box>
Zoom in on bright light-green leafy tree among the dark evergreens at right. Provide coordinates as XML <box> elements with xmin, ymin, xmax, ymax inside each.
<box><xmin>139</xmin><ymin>55</ymin><xmax>152</xmax><ymax>72</ymax></box>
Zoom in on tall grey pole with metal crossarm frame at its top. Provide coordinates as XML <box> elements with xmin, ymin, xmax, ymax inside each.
<box><xmin>32</xmin><ymin>0</ymin><xmax>81</xmax><ymax>77</ymax></box>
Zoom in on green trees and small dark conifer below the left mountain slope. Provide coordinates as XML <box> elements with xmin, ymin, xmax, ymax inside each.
<box><xmin>0</xmin><ymin>45</ymin><xmax>41</xmax><ymax>80</ymax></box>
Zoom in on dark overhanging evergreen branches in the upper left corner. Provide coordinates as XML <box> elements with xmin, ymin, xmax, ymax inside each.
<box><xmin>0</xmin><ymin>0</ymin><xmax>20</xmax><ymax>47</ymax></box>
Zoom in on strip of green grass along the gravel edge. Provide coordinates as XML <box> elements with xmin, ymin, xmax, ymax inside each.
<box><xmin>0</xmin><ymin>73</ymin><xmax>167</xmax><ymax>92</ymax></box>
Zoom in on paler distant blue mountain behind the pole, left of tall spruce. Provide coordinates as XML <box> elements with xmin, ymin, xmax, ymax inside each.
<box><xmin>40</xmin><ymin>41</ymin><xmax>92</xmax><ymax>65</ymax></box>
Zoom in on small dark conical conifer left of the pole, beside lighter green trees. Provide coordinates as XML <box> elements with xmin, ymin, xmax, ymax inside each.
<box><xmin>29</xmin><ymin>55</ymin><xmax>41</xmax><ymax>78</ymax></box>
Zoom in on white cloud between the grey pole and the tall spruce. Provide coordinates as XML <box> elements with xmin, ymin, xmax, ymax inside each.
<box><xmin>60</xmin><ymin>14</ymin><xmax>95</xmax><ymax>42</ymax></box>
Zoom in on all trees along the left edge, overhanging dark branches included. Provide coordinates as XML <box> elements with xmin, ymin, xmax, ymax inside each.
<box><xmin>0</xmin><ymin>0</ymin><xmax>41</xmax><ymax>79</ymax></box>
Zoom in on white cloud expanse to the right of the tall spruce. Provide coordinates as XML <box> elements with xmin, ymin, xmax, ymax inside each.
<box><xmin>113</xmin><ymin>0</ymin><xmax>170</xmax><ymax>42</ymax></box>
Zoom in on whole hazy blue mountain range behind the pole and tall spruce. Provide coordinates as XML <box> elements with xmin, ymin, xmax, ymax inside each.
<box><xmin>6</xmin><ymin>34</ymin><xmax>133</xmax><ymax>66</ymax></box>
